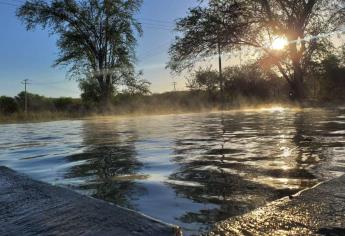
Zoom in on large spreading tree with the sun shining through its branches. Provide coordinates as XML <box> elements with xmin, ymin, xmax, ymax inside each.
<box><xmin>168</xmin><ymin>0</ymin><xmax>344</xmax><ymax>100</ymax></box>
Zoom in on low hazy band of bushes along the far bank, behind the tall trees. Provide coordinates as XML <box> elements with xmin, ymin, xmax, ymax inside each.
<box><xmin>0</xmin><ymin>51</ymin><xmax>345</xmax><ymax>118</ymax></box>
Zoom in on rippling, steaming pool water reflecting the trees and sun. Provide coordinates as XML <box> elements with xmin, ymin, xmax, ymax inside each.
<box><xmin>0</xmin><ymin>109</ymin><xmax>345</xmax><ymax>235</ymax></box>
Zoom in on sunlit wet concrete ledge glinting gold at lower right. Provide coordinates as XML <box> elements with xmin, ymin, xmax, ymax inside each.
<box><xmin>209</xmin><ymin>176</ymin><xmax>345</xmax><ymax>235</ymax></box>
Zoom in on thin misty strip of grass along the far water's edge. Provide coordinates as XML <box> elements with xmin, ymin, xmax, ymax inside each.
<box><xmin>0</xmin><ymin>94</ymin><xmax>334</xmax><ymax>123</ymax></box>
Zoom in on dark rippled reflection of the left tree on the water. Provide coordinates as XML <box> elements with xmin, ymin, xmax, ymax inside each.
<box><xmin>64</xmin><ymin>123</ymin><xmax>142</xmax><ymax>208</ymax></box>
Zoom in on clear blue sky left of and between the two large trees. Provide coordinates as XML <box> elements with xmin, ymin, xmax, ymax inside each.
<box><xmin>0</xmin><ymin>0</ymin><xmax>198</xmax><ymax>97</ymax></box>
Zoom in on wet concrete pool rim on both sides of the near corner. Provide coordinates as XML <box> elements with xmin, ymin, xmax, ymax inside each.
<box><xmin>0</xmin><ymin>167</ymin><xmax>345</xmax><ymax>236</ymax></box>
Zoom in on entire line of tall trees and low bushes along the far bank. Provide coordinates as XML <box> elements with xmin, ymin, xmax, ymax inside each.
<box><xmin>14</xmin><ymin>0</ymin><xmax>345</xmax><ymax>114</ymax></box>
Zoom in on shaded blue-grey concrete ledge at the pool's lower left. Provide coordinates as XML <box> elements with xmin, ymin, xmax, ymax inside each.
<box><xmin>0</xmin><ymin>167</ymin><xmax>181</xmax><ymax>236</ymax></box>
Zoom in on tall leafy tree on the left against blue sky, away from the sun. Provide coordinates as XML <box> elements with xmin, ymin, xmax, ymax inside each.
<box><xmin>17</xmin><ymin>0</ymin><xmax>142</xmax><ymax>107</ymax></box>
